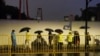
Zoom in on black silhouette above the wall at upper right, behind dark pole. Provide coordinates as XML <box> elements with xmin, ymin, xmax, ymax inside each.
<box><xmin>81</xmin><ymin>3</ymin><xmax>100</xmax><ymax>21</ymax></box>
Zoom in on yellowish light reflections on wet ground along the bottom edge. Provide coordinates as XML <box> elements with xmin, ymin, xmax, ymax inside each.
<box><xmin>0</xmin><ymin>52</ymin><xmax>100</xmax><ymax>56</ymax></box>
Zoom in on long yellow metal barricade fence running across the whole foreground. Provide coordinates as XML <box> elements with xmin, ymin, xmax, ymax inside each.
<box><xmin>0</xmin><ymin>35</ymin><xmax>100</xmax><ymax>54</ymax></box>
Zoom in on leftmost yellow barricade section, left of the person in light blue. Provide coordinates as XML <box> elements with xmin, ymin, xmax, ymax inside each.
<box><xmin>0</xmin><ymin>34</ymin><xmax>11</xmax><ymax>55</ymax></box>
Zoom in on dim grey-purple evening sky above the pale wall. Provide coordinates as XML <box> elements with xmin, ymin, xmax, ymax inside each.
<box><xmin>5</xmin><ymin>0</ymin><xmax>100</xmax><ymax>20</ymax></box>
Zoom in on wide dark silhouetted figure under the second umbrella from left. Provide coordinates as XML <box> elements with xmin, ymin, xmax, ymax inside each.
<box><xmin>32</xmin><ymin>30</ymin><xmax>47</xmax><ymax>56</ymax></box>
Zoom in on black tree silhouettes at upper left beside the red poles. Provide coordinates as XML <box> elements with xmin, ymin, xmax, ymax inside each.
<box><xmin>0</xmin><ymin>0</ymin><xmax>28</xmax><ymax>19</ymax></box>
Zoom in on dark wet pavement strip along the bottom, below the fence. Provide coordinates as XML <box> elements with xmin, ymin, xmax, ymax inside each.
<box><xmin>0</xmin><ymin>52</ymin><xmax>100</xmax><ymax>56</ymax></box>
